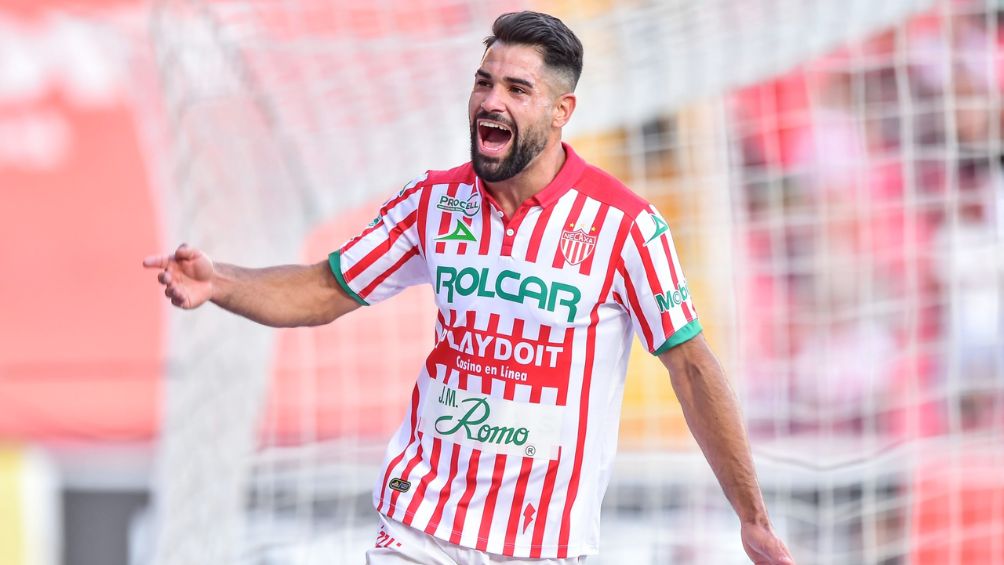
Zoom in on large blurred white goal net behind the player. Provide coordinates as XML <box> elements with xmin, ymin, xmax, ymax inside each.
<box><xmin>149</xmin><ymin>0</ymin><xmax>1004</xmax><ymax>565</ymax></box>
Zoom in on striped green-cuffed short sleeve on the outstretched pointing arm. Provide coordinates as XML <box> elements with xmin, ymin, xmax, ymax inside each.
<box><xmin>328</xmin><ymin>176</ymin><xmax>429</xmax><ymax>305</ymax></box>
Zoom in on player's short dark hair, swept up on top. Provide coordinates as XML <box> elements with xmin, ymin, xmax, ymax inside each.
<box><xmin>485</xmin><ymin>11</ymin><xmax>582</xmax><ymax>90</ymax></box>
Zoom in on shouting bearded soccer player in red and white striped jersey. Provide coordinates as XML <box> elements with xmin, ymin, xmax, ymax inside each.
<box><xmin>144</xmin><ymin>12</ymin><xmax>793</xmax><ymax>564</ymax></box>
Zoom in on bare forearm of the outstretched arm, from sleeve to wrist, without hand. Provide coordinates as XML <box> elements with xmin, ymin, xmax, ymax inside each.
<box><xmin>210</xmin><ymin>261</ymin><xmax>359</xmax><ymax>327</ymax></box>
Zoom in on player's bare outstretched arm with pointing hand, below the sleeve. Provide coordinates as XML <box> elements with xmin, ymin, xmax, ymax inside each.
<box><xmin>143</xmin><ymin>244</ymin><xmax>359</xmax><ymax>327</ymax></box>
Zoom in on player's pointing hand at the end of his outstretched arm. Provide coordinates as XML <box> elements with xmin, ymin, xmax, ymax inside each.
<box><xmin>143</xmin><ymin>243</ymin><xmax>215</xmax><ymax>310</ymax></box>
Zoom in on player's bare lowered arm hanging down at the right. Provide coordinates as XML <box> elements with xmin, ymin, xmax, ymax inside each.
<box><xmin>660</xmin><ymin>334</ymin><xmax>794</xmax><ymax>565</ymax></box>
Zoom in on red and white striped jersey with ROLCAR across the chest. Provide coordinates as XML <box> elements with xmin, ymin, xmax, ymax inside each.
<box><xmin>329</xmin><ymin>146</ymin><xmax>701</xmax><ymax>558</ymax></box>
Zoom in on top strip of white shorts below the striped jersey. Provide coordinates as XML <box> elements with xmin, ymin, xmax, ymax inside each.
<box><xmin>366</xmin><ymin>514</ymin><xmax>585</xmax><ymax>565</ymax></box>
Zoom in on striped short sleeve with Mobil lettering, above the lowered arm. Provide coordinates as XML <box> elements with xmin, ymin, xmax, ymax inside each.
<box><xmin>613</xmin><ymin>205</ymin><xmax>701</xmax><ymax>355</ymax></box>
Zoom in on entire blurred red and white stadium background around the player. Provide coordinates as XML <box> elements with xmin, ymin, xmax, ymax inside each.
<box><xmin>0</xmin><ymin>0</ymin><xmax>1004</xmax><ymax>565</ymax></box>
